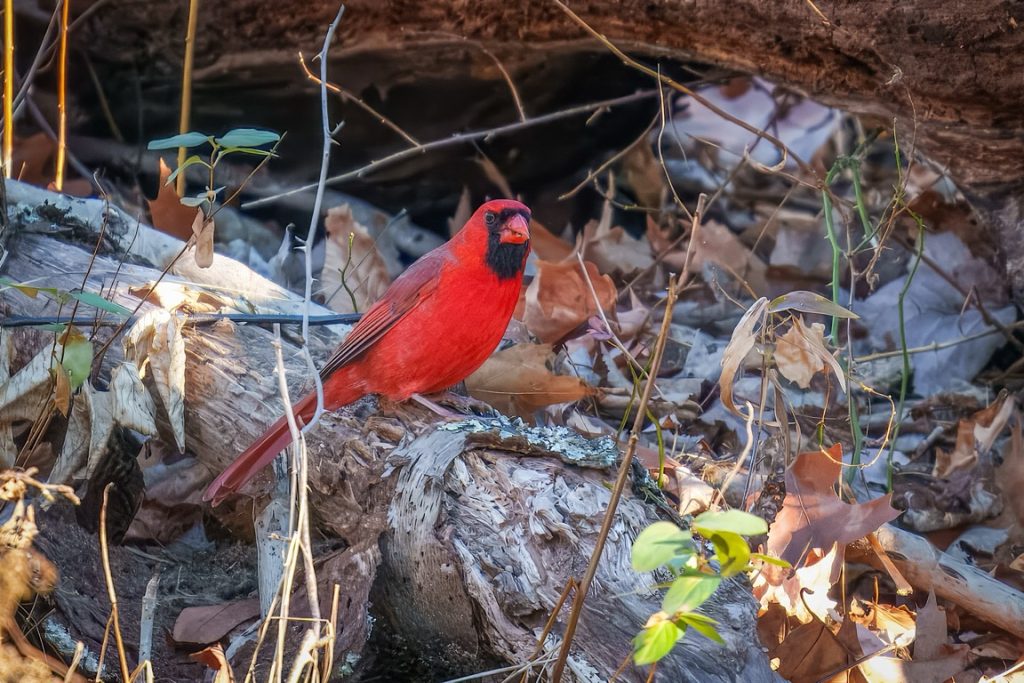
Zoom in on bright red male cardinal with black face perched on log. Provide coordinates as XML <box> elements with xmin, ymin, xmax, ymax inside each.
<box><xmin>203</xmin><ymin>200</ymin><xmax>530</xmax><ymax>505</ymax></box>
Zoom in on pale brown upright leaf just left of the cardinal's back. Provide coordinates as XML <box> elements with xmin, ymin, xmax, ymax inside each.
<box><xmin>321</xmin><ymin>204</ymin><xmax>391</xmax><ymax>313</ymax></box>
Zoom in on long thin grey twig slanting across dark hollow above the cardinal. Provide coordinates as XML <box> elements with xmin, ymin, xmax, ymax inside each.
<box><xmin>242</xmin><ymin>89</ymin><xmax>657</xmax><ymax>209</ymax></box>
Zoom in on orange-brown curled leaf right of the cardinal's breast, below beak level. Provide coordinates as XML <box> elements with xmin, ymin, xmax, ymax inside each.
<box><xmin>522</xmin><ymin>259</ymin><xmax>616</xmax><ymax>344</ymax></box>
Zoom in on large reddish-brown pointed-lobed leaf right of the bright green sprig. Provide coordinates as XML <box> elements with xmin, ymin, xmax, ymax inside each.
<box><xmin>768</xmin><ymin>443</ymin><xmax>899</xmax><ymax>566</ymax></box>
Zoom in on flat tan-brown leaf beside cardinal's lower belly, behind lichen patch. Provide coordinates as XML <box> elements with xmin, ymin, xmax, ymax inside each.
<box><xmin>466</xmin><ymin>344</ymin><xmax>594</xmax><ymax>420</ymax></box>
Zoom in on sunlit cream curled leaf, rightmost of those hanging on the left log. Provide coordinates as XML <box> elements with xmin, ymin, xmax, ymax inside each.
<box><xmin>125</xmin><ymin>308</ymin><xmax>185</xmax><ymax>453</ymax></box>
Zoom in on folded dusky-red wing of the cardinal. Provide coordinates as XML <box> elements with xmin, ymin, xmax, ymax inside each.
<box><xmin>321</xmin><ymin>251</ymin><xmax>446</xmax><ymax>379</ymax></box>
